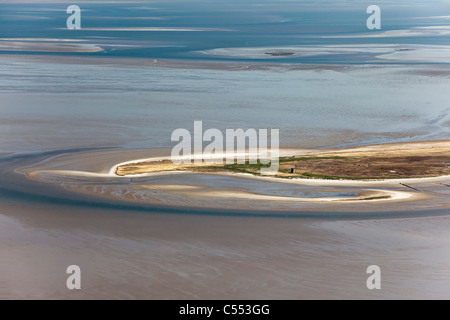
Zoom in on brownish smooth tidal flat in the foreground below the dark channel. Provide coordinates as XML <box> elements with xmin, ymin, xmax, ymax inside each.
<box><xmin>0</xmin><ymin>202</ymin><xmax>450</xmax><ymax>299</ymax></box>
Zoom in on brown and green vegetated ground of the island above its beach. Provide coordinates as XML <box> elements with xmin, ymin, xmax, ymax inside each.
<box><xmin>115</xmin><ymin>142</ymin><xmax>450</xmax><ymax>180</ymax></box>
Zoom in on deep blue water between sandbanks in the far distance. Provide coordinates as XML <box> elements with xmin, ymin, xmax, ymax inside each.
<box><xmin>0</xmin><ymin>0</ymin><xmax>450</xmax><ymax>63</ymax></box>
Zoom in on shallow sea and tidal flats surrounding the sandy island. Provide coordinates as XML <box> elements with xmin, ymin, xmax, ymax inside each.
<box><xmin>0</xmin><ymin>1</ymin><xmax>450</xmax><ymax>299</ymax></box>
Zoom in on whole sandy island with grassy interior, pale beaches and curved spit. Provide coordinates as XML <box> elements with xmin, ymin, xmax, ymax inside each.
<box><xmin>19</xmin><ymin>141</ymin><xmax>450</xmax><ymax>210</ymax></box>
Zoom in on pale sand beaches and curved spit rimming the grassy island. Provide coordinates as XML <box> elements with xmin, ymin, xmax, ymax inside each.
<box><xmin>22</xmin><ymin>141</ymin><xmax>450</xmax><ymax>204</ymax></box>
